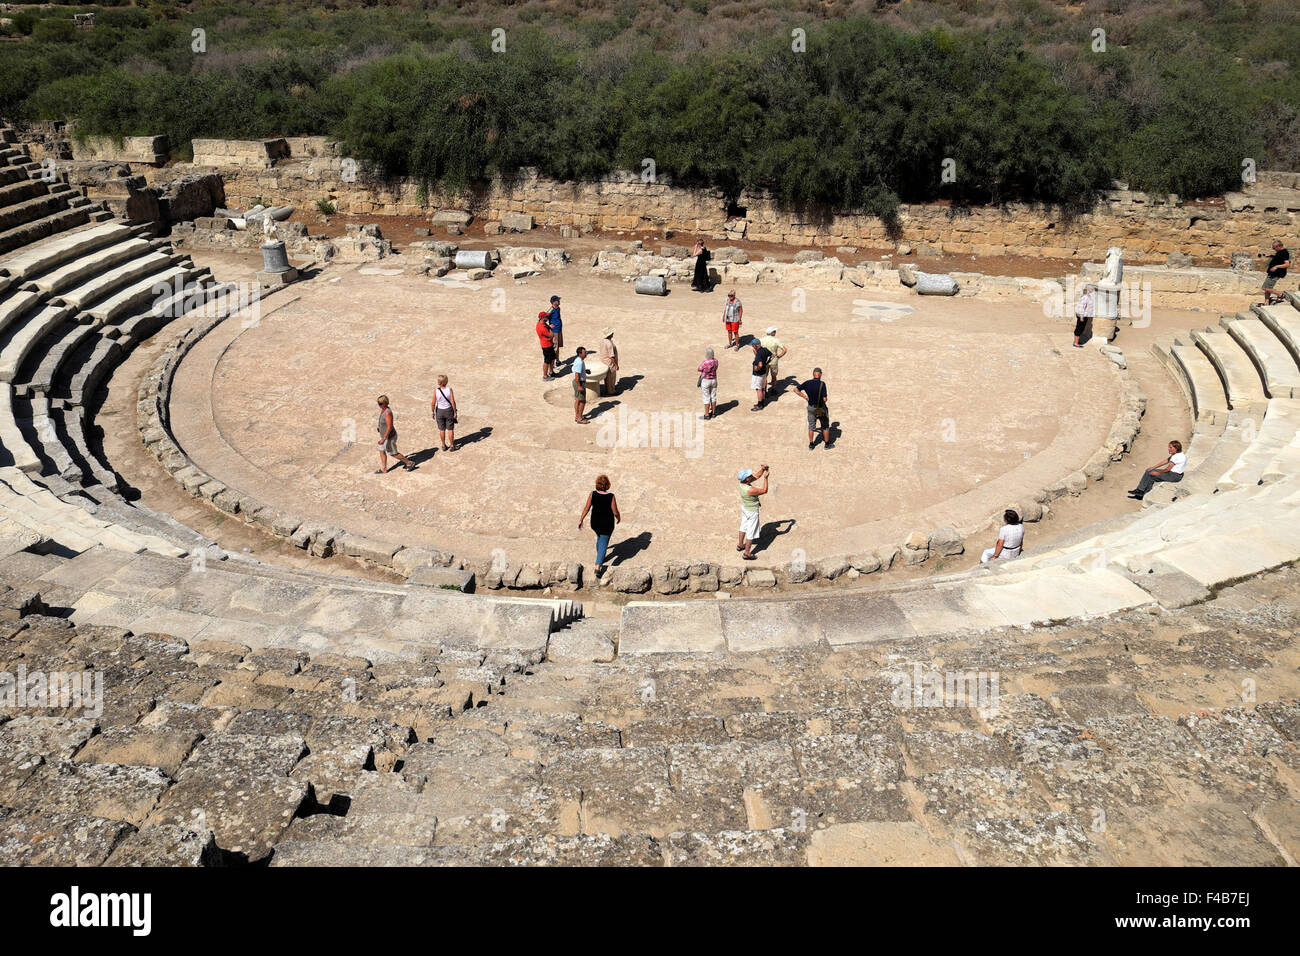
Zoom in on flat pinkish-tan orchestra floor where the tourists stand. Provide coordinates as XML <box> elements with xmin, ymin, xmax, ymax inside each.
<box><xmin>144</xmin><ymin>251</ymin><xmax>1213</xmax><ymax>570</ymax></box>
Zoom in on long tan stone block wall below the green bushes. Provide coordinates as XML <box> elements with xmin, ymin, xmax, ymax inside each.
<box><xmin>162</xmin><ymin>137</ymin><xmax>1300</xmax><ymax>265</ymax></box>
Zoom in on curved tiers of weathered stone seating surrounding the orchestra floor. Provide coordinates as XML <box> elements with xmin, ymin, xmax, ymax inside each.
<box><xmin>0</xmin><ymin>130</ymin><xmax>1300</xmax><ymax>866</ymax></box>
